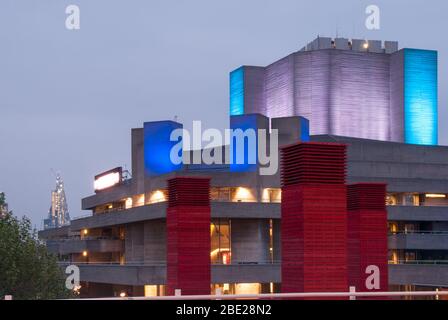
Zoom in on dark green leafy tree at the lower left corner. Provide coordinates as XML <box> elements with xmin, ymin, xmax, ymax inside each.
<box><xmin>0</xmin><ymin>197</ymin><xmax>72</xmax><ymax>299</ymax></box>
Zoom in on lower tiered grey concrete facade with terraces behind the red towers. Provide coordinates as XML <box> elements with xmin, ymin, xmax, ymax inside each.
<box><xmin>40</xmin><ymin>118</ymin><xmax>448</xmax><ymax>296</ymax></box>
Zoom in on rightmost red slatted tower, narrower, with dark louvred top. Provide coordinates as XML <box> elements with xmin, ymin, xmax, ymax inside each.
<box><xmin>347</xmin><ymin>183</ymin><xmax>388</xmax><ymax>298</ymax></box>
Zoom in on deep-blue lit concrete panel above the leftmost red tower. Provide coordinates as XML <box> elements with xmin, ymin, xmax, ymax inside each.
<box><xmin>143</xmin><ymin>121</ymin><xmax>182</xmax><ymax>176</ymax></box>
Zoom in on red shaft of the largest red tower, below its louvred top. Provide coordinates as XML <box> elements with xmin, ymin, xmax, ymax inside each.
<box><xmin>281</xmin><ymin>184</ymin><xmax>348</xmax><ymax>298</ymax></box>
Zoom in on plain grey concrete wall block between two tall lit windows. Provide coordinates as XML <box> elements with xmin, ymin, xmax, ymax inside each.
<box><xmin>231</xmin><ymin>219</ymin><xmax>270</xmax><ymax>263</ymax></box>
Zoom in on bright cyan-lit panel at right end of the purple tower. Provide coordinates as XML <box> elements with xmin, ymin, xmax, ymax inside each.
<box><xmin>404</xmin><ymin>49</ymin><xmax>438</xmax><ymax>145</ymax></box>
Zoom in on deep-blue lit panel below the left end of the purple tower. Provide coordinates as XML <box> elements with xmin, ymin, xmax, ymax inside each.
<box><xmin>230</xmin><ymin>114</ymin><xmax>258</xmax><ymax>172</ymax></box>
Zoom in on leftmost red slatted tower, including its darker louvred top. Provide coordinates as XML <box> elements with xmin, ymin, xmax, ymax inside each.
<box><xmin>166</xmin><ymin>177</ymin><xmax>211</xmax><ymax>295</ymax></box>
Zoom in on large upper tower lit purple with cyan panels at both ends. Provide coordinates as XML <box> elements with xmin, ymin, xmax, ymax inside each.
<box><xmin>230</xmin><ymin>38</ymin><xmax>437</xmax><ymax>145</ymax></box>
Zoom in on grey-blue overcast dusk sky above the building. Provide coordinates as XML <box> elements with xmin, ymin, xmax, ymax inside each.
<box><xmin>0</xmin><ymin>0</ymin><xmax>448</xmax><ymax>228</ymax></box>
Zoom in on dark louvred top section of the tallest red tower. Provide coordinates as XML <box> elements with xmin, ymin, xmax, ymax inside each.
<box><xmin>281</xmin><ymin>142</ymin><xmax>347</xmax><ymax>186</ymax></box>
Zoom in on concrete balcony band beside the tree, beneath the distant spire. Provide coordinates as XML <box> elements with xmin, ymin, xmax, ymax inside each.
<box><xmin>47</xmin><ymin>239</ymin><xmax>124</xmax><ymax>254</ymax></box>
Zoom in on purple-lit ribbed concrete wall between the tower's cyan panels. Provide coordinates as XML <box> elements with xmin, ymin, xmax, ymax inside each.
<box><xmin>244</xmin><ymin>49</ymin><xmax>396</xmax><ymax>140</ymax></box>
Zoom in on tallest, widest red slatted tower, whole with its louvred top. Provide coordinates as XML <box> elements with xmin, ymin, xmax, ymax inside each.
<box><xmin>281</xmin><ymin>143</ymin><xmax>348</xmax><ymax>298</ymax></box>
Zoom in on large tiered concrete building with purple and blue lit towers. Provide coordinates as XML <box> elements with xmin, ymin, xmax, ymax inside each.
<box><xmin>39</xmin><ymin>38</ymin><xmax>448</xmax><ymax>297</ymax></box>
